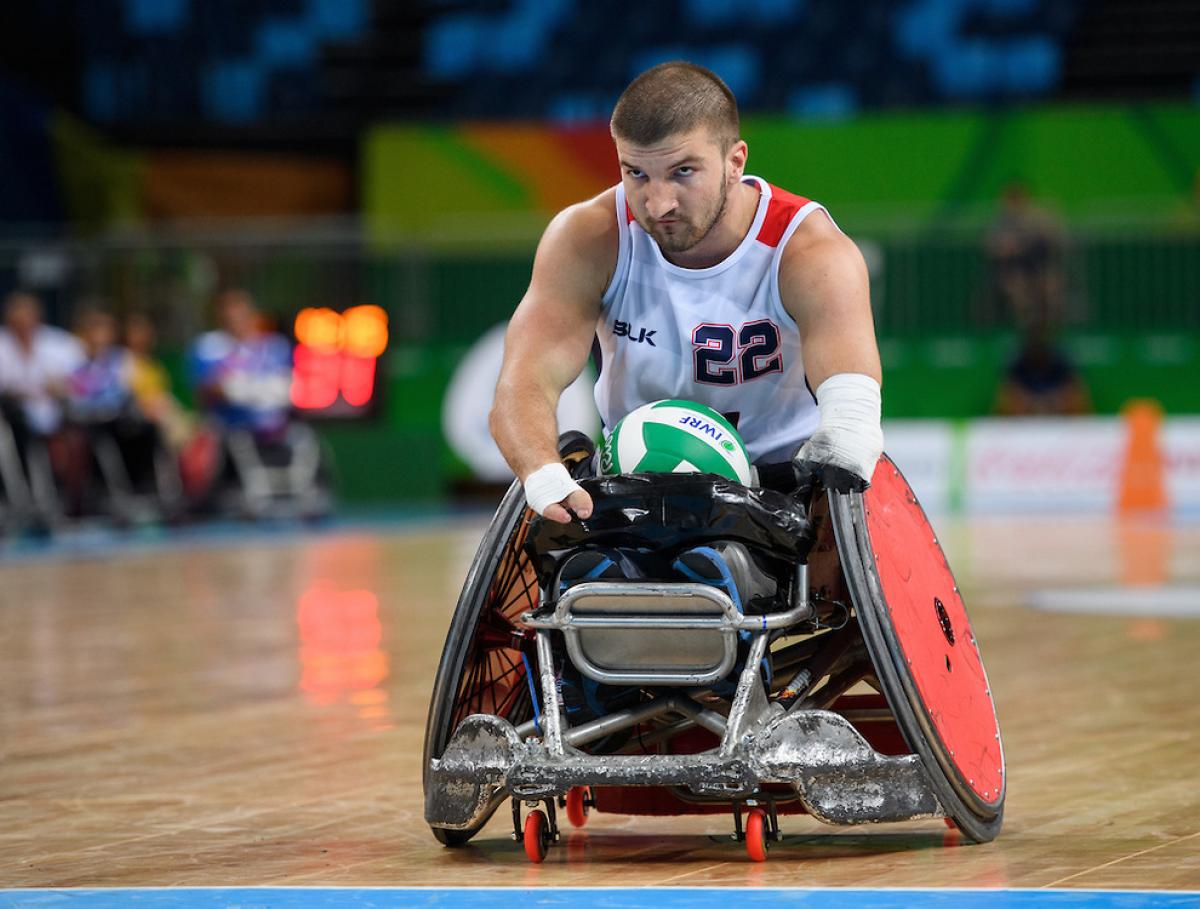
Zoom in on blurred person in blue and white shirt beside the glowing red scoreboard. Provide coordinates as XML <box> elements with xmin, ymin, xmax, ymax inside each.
<box><xmin>191</xmin><ymin>289</ymin><xmax>292</xmax><ymax>438</ymax></box>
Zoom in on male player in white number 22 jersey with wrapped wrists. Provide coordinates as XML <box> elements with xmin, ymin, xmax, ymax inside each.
<box><xmin>490</xmin><ymin>62</ymin><xmax>883</xmax><ymax>523</ymax></box>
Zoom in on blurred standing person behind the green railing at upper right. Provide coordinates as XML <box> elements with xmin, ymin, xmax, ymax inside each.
<box><xmin>986</xmin><ymin>181</ymin><xmax>1067</xmax><ymax>332</ymax></box>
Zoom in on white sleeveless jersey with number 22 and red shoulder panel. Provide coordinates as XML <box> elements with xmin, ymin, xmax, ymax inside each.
<box><xmin>595</xmin><ymin>176</ymin><xmax>828</xmax><ymax>463</ymax></box>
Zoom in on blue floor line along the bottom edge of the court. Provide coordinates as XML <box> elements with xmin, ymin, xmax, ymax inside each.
<box><xmin>0</xmin><ymin>887</ymin><xmax>1200</xmax><ymax>909</ymax></box>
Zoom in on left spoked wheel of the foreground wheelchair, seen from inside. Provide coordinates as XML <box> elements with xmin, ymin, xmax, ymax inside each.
<box><xmin>421</xmin><ymin>433</ymin><xmax>594</xmax><ymax>845</ymax></box>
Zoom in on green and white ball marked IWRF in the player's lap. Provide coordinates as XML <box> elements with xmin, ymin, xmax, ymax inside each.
<box><xmin>600</xmin><ymin>401</ymin><xmax>750</xmax><ymax>486</ymax></box>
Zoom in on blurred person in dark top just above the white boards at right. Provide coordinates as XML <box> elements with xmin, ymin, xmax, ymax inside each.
<box><xmin>996</xmin><ymin>331</ymin><xmax>1092</xmax><ymax>416</ymax></box>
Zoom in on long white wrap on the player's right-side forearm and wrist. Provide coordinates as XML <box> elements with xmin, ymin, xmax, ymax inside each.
<box><xmin>796</xmin><ymin>373</ymin><xmax>883</xmax><ymax>482</ymax></box>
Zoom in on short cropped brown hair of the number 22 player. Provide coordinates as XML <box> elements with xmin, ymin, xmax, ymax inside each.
<box><xmin>610</xmin><ymin>60</ymin><xmax>740</xmax><ymax>151</ymax></box>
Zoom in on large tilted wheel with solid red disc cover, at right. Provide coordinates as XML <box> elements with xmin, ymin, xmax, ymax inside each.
<box><xmin>829</xmin><ymin>455</ymin><xmax>1004</xmax><ymax>843</ymax></box>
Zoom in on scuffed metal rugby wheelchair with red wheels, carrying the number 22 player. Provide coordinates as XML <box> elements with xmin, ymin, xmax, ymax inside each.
<box><xmin>422</xmin><ymin>434</ymin><xmax>1004</xmax><ymax>862</ymax></box>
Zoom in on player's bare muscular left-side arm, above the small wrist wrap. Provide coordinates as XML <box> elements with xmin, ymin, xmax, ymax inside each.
<box><xmin>488</xmin><ymin>192</ymin><xmax>618</xmax><ymax>520</ymax></box>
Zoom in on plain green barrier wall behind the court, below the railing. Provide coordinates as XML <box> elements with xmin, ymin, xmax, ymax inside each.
<box><xmin>166</xmin><ymin>332</ymin><xmax>1200</xmax><ymax>504</ymax></box>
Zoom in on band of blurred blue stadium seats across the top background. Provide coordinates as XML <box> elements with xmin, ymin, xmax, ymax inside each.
<box><xmin>70</xmin><ymin>0</ymin><xmax>1085</xmax><ymax>125</ymax></box>
